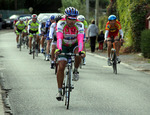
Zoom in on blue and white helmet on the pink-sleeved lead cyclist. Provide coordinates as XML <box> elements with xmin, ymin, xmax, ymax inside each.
<box><xmin>65</xmin><ymin>7</ymin><xmax>79</xmax><ymax>17</ymax></box>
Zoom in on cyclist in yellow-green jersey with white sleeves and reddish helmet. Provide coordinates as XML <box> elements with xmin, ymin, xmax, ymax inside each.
<box><xmin>28</xmin><ymin>14</ymin><xmax>40</xmax><ymax>54</ymax></box>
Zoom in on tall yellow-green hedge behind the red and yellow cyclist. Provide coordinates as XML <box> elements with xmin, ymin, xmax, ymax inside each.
<box><xmin>117</xmin><ymin>0</ymin><xmax>147</xmax><ymax>52</ymax></box>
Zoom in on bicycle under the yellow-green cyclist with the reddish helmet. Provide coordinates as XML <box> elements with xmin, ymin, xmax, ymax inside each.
<box><xmin>32</xmin><ymin>33</ymin><xmax>38</xmax><ymax>59</ymax></box>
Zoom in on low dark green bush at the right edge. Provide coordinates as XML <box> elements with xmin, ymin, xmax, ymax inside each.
<box><xmin>141</xmin><ymin>30</ymin><xmax>150</xmax><ymax>58</ymax></box>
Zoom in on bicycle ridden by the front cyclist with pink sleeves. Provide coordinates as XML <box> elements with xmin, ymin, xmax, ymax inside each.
<box><xmin>59</xmin><ymin>53</ymin><xmax>79</xmax><ymax>109</ymax></box>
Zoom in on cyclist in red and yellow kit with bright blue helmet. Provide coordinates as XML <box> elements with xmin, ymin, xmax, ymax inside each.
<box><xmin>105</xmin><ymin>15</ymin><xmax>124</xmax><ymax>66</ymax></box>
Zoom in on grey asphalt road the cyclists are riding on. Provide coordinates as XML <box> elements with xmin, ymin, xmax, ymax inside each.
<box><xmin>0</xmin><ymin>32</ymin><xmax>150</xmax><ymax>115</ymax></box>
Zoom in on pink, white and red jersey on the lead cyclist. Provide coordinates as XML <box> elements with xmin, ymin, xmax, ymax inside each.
<box><xmin>56</xmin><ymin>18</ymin><xmax>84</xmax><ymax>52</ymax></box>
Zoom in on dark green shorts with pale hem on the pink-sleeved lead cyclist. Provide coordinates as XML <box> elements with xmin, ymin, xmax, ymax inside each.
<box><xmin>58</xmin><ymin>43</ymin><xmax>78</xmax><ymax>61</ymax></box>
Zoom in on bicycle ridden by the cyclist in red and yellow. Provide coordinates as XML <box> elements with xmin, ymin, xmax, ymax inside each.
<box><xmin>107</xmin><ymin>36</ymin><xmax>120</xmax><ymax>74</ymax></box>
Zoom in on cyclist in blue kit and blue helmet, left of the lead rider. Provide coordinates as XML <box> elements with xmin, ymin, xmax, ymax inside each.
<box><xmin>46</xmin><ymin>15</ymin><xmax>55</xmax><ymax>61</ymax></box>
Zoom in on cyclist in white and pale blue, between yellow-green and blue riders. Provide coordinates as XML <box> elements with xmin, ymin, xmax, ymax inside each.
<box><xmin>39</xmin><ymin>16</ymin><xmax>47</xmax><ymax>53</ymax></box>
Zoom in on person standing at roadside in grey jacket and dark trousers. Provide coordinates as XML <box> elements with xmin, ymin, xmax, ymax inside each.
<box><xmin>88</xmin><ymin>20</ymin><xmax>98</xmax><ymax>53</ymax></box>
